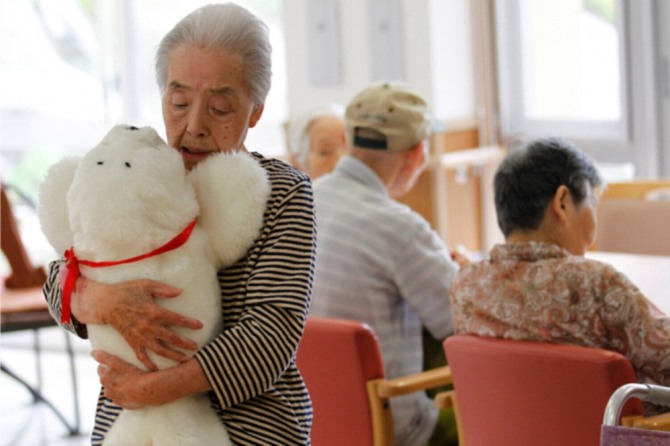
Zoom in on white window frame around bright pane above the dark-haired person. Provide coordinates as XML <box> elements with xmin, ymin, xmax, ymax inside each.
<box><xmin>490</xmin><ymin>0</ymin><xmax>670</xmax><ymax>178</ymax></box>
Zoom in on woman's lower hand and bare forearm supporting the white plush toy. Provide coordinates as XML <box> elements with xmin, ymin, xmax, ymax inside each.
<box><xmin>91</xmin><ymin>350</ymin><xmax>211</xmax><ymax>409</ymax></box>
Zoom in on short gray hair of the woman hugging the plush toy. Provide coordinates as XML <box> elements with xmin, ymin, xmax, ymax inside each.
<box><xmin>156</xmin><ymin>3</ymin><xmax>272</xmax><ymax>104</ymax></box>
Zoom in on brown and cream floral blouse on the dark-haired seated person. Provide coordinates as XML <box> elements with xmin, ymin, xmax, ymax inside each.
<box><xmin>451</xmin><ymin>242</ymin><xmax>670</xmax><ymax>386</ymax></box>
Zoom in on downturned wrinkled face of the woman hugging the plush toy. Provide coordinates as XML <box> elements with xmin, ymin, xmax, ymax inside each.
<box><xmin>163</xmin><ymin>44</ymin><xmax>263</xmax><ymax>170</ymax></box>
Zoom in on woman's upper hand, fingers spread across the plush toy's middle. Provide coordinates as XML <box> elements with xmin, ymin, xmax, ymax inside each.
<box><xmin>72</xmin><ymin>276</ymin><xmax>202</xmax><ymax>370</ymax></box>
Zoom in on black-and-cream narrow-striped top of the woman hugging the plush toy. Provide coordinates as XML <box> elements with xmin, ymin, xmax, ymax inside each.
<box><xmin>44</xmin><ymin>153</ymin><xmax>316</xmax><ymax>446</ymax></box>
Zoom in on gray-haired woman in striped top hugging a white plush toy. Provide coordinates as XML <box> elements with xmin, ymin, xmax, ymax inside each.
<box><xmin>44</xmin><ymin>3</ymin><xmax>316</xmax><ymax>445</ymax></box>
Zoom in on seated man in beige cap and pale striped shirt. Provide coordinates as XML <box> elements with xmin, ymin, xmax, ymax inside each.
<box><xmin>310</xmin><ymin>83</ymin><xmax>459</xmax><ymax>445</ymax></box>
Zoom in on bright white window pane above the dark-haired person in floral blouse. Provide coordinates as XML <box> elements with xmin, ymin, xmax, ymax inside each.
<box><xmin>497</xmin><ymin>0</ymin><xmax>628</xmax><ymax>141</ymax></box>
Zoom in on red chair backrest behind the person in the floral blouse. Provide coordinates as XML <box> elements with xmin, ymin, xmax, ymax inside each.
<box><xmin>444</xmin><ymin>335</ymin><xmax>642</xmax><ymax>446</ymax></box>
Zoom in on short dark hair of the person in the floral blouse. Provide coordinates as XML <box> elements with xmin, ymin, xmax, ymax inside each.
<box><xmin>494</xmin><ymin>138</ymin><xmax>603</xmax><ymax>237</ymax></box>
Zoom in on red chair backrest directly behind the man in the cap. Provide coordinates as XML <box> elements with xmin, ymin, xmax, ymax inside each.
<box><xmin>296</xmin><ymin>317</ymin><xmax>385</xmax><ymax>446</ymax></box>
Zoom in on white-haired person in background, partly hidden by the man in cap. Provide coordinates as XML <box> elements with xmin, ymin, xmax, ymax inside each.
<box><xmin>288</xmin><ymin>103</ymin><xmax>346</xmax><ymax>180</ymax></box>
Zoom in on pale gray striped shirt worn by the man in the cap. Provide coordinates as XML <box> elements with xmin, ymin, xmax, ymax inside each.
<box><xmin>310</xmin><ymin>156</ymin><xmax>458</xmax><ymax>445</ymax></box>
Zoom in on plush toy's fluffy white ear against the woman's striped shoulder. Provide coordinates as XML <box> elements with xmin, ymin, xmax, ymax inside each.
<box><xmin>190</xmin><ymin>152</ymin><xmax>270</xmax><ymax>266</ymax></box>
